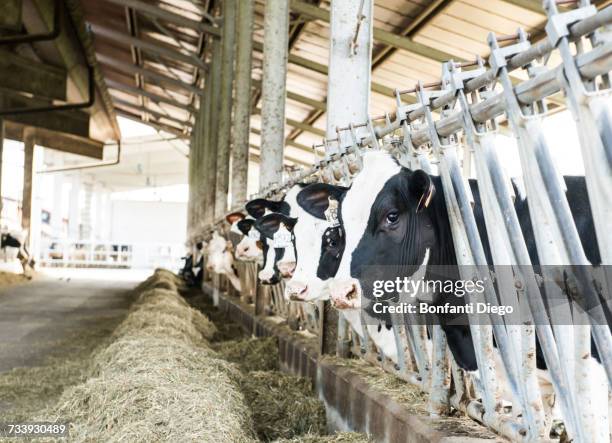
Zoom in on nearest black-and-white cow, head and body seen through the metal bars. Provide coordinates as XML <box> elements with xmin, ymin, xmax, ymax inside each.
<box><xmin>322</xmin><ymin>152</ymin><xmax>606</xmax><ymax>438</ymax></box>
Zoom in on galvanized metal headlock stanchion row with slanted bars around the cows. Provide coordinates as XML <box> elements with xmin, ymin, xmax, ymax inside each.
<box><xmin>197</xmin><ymin>0</ymin><xmax>612</xmax><ymax>443</ymax></box>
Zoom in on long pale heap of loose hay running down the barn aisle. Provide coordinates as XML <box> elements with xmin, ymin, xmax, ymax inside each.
<box><xmin>41</xmin><ymin>270</ymin><xmax>255</xmax><ymax>443</ymax></box>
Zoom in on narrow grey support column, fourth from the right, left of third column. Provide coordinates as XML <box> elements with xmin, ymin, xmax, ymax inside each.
<box><xmin>215</xmin><ymin>0</ymin><xmax>236</xmax><ymax>219</ymax></box>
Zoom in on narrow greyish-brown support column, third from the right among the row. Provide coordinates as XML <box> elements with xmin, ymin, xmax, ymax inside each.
<box><xmin>231</xmin><ymin>1</ymin><xmax>255</xmax><ymax>207</ymax></box>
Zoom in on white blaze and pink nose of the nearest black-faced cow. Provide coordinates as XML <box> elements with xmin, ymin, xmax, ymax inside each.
<box><xmin>329</xmin><ymin>151</ymin><xmax>401</xmax><ymax>309</ymax></box>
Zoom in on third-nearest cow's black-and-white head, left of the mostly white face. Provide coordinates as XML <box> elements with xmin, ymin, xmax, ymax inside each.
<box><xmin>256</xmin><ymin>213</ymin><xmax>297</xmax><ymax>278</ymax></box>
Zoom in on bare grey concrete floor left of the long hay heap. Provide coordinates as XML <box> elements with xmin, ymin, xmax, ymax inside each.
<box><xmin>0</xmin><ymin>270</ymin><xmax>142</xmax><ymax>372</ymax></box>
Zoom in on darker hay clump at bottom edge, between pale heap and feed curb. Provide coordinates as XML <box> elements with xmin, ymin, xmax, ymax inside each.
<box><xmin>240</xmin><ymin>371</ymin><xmax>326</xmax><ymax>441</ymax></box>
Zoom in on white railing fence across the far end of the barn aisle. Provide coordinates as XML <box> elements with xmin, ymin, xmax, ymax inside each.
<box><xmin>39</xmin><ymin>239</ymin><xmax>185</xmax><ymax>269</ymax></box>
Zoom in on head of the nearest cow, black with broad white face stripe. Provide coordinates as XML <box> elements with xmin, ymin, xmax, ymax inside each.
<box><xmin>330</xmin><ymin>152</ymin><xmax>438</xmax><ymax>309</ymax></box>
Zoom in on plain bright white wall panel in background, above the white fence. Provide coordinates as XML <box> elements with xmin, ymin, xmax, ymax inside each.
<box><xmin>109</xmin><ymin>200</ymin><xmax>187</xmax><ymax>243</ymax></box>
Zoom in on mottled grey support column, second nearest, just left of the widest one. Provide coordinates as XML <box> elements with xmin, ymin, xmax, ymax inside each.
<box><xmin>259</xmin><ymin>0</ymin><xmax>289</xmax><ymax>189</ymax></box>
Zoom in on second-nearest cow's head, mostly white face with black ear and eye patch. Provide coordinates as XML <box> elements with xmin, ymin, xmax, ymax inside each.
<box><xmin>285</xmin><ymin>183</ymin><xmax>348</xmax><ymax>301</ymax></box>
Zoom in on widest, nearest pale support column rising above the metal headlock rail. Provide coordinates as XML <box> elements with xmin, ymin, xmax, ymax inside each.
<box><xmin>326</xmin><ymin>0</ymin><xmax>374</xmax><ymax>151</ymax></box>
